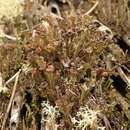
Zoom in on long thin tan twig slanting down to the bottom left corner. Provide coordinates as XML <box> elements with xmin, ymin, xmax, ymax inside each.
<box><xmin>1</xmin><ymin>69</ymin><xmax>21</xmax><ymax>130</ymax></box>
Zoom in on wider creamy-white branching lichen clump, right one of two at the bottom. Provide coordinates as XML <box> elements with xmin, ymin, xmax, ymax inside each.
<box><xmin>71</xmin><ymin>106</ymin><xmax>99</xmax><ymax>130</ymax></box>
